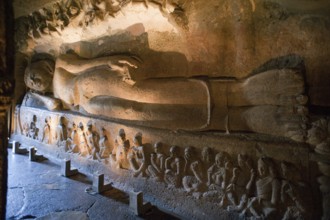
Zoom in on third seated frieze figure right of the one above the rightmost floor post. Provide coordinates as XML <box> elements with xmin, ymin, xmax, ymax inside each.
<box><xmin>182</xmin><ymin>146</ymin><xmax>206</xmax><ymax>193</ymax></box>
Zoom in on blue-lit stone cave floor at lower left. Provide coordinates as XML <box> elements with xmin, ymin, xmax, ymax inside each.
<box><xmin>6</xmin><ymin>149</ymin><xmax>178</xmax><ymax>220</ymax></box>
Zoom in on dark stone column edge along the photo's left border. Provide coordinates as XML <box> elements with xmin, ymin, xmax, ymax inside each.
<box><xmin>0</xmin><ymin>1</ymin><xmax>14</xmax><ymax>219</ymax></box>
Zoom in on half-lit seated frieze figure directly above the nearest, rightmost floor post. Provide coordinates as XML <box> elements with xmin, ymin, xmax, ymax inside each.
<box><xmin>127</xmin><ymin>132</ymin><xmax>149</xmax><ymax>177</ymax></box>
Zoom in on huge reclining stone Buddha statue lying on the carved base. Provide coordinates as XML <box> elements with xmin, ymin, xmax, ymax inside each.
<box><xmin>25</xmin><ymin>51</ymin><xmax>306</xmax><ymax>141</ymax></box>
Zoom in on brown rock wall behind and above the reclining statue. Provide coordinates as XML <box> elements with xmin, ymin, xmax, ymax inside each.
<box><xmin>14</xmin><ymin>0</ymin><xmax>330</xmax><ymax>106</ymax></box>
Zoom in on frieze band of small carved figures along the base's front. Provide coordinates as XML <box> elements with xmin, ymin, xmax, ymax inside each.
<box><xmin>10</xmin><ymin>107</ymin><xmax>314</xmax><ymax>219</ymax></box>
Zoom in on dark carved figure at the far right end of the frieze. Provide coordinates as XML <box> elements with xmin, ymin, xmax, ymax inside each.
<box><xmin>281</xmin><ymin>162</ymin><xmax>311</xmax><ymax>220</ymax></box>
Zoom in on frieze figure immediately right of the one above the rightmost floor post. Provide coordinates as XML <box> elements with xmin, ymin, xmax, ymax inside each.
<box><xmin>148</xmin><ymin>142</ymin><xmax>165</xmax><ymax>181</ymax></box>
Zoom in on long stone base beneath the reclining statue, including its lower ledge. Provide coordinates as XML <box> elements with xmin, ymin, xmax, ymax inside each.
<box><xmin>12</xmin><ymin>106</ymin><xmax>319</xmax><ymax>219</ymax></box>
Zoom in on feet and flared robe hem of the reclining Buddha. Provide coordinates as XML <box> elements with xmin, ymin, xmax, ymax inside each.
<box><xmin>228</xmin><ymin>69</ymin><xmax>308</xmax><ymax>141</ymax></box>
